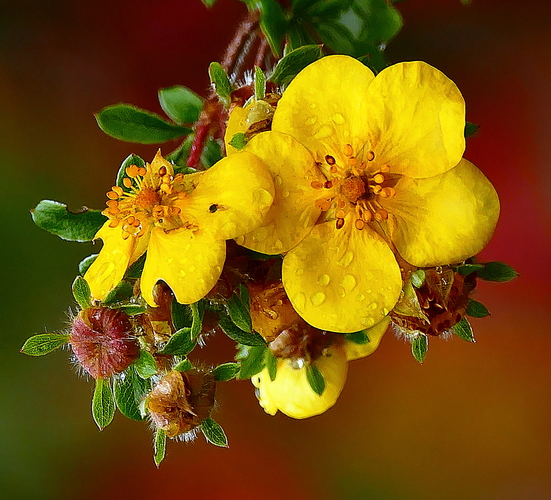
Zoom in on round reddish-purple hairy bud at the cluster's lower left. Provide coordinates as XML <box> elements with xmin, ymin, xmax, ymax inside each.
<box><xmin>69</xmin><ymin>307</ymin><xmax>140</xmax><ymax>379</ymax></box>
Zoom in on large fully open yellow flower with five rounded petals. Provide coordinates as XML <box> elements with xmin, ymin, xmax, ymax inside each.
<box><xmin>233</xmin><ymin>56</ymin><xmax>499</xmax><ymax>332</ymax></box>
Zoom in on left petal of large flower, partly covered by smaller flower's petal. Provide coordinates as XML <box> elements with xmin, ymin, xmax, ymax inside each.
<box><xmin>236</xmin><ymin>132</ymin><xmax>326</xmax><ymax>254</ymax></box>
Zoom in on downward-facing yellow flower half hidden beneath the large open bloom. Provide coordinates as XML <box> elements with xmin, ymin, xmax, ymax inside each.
<box><xmin>251</xmin><ymin>318</ymin><xmax>390</xmax><ymax>418</ymax></box>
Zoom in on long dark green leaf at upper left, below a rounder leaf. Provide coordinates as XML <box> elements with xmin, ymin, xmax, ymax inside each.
<box><xmin>96</xmin><ymin>104</ymin><xmax>191</xmax><ymax>144</ymax></box>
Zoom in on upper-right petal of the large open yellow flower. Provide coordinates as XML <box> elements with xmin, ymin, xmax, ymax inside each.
<box><xmin>366</xmin><ymin>61</ymin><xmax>465</xmax><ymax>177</ymax></box>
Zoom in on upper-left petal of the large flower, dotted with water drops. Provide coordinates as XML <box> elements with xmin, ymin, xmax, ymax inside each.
<box><xmin>272</xmin><ymin>55</ymin><xmax>374</xmax><ymax>165</ymax></box>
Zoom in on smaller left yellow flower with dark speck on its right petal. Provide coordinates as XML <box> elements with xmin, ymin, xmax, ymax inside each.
<box><xmin>84</xmin><ymin>152</ymin><xmax>274</xmax><ymax>306</ymax></box>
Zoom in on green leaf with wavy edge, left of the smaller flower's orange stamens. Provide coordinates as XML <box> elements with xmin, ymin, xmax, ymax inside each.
<box><xmin>31</xmin><ymin>200</ymin><xmax>107</xmax><ymax>242</ymax></box>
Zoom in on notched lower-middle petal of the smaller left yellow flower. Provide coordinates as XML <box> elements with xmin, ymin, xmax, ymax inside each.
<box><xmin>140</xmin><ymin>227</ymin><xmax>226</xmax><ymax>307</ymax></box>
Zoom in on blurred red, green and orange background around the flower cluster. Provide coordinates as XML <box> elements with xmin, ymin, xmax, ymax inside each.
<box><xmin>0</xmin><ymin>0</ymin><xmax>551</xmax><ymax>500</ymax></box>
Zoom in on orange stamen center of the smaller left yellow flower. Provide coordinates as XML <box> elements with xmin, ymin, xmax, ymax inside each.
<box><xmin>102</xmin><ymin>164</ymin><xmax>192</xmax><ymax>239</ymax></box>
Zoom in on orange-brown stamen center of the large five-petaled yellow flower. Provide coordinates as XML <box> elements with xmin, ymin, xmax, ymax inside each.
<box><xmin>312</xmin><ymin>144</ymin><xmax>400</xmax><ymax>230</ymax></box>
